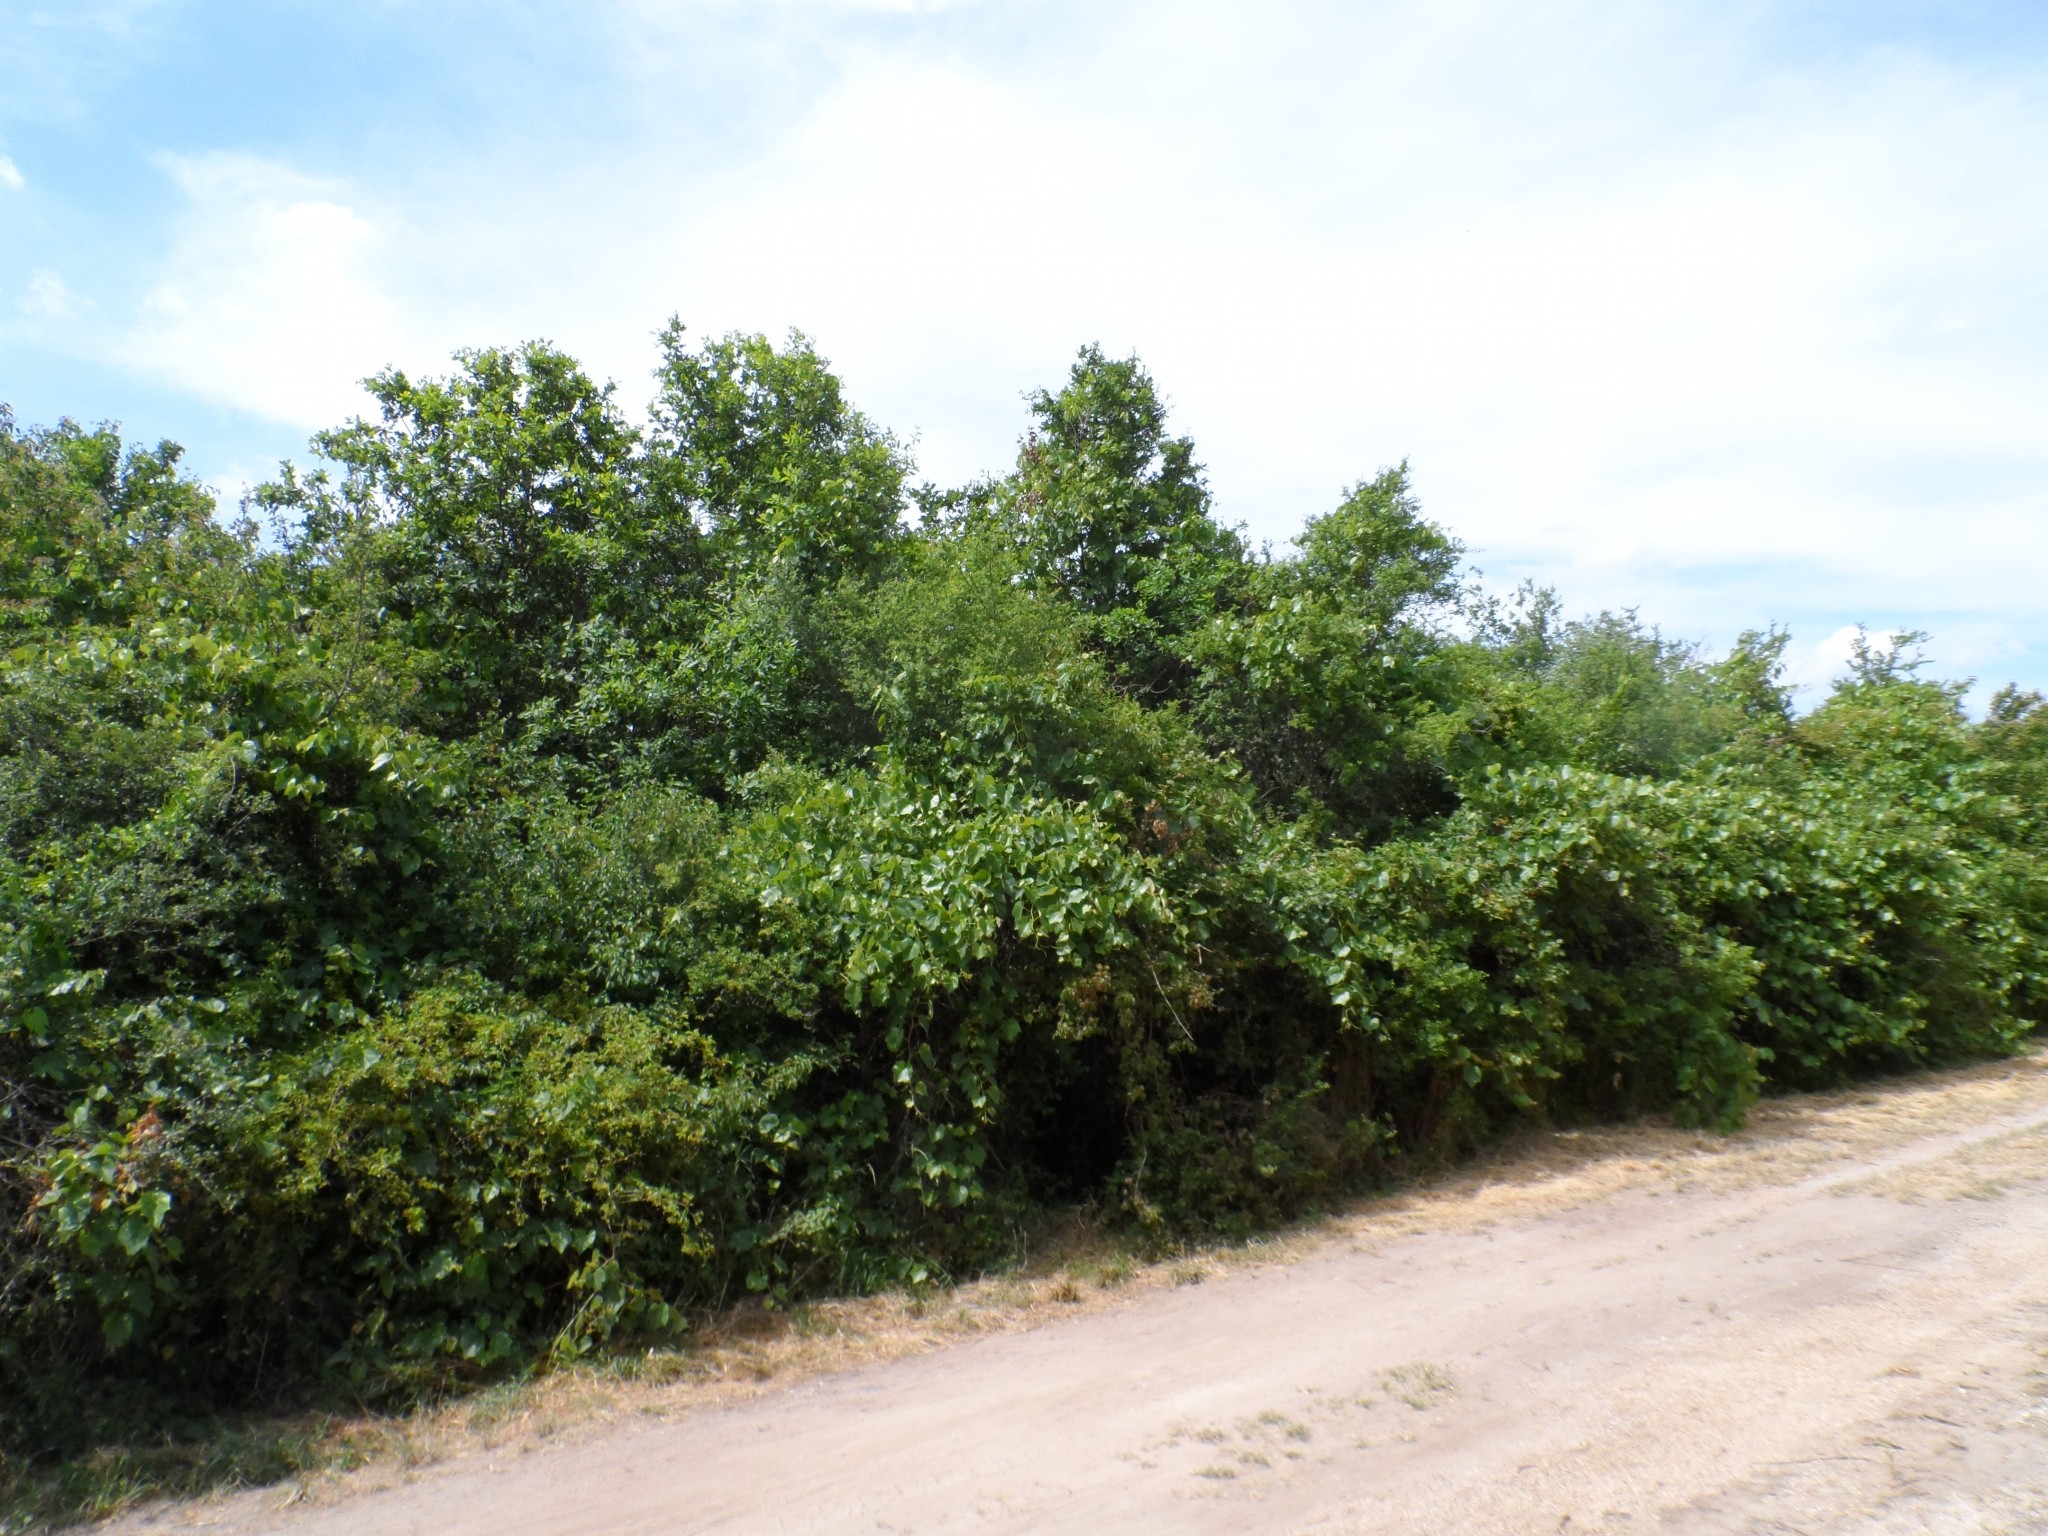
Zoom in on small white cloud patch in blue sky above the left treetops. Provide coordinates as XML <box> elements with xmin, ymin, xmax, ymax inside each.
<box><xmin>119</xmin><ymin>156</ymin><xmax>438</xmax><ymax>428</ymax></box>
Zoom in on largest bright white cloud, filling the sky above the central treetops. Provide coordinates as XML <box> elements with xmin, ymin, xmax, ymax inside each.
<box><xmin>548</xmin><ymin>6</ymin><xmax>2048</xmax><ymax>598</ymax></box>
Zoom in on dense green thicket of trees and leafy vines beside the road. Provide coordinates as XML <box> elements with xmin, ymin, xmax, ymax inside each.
<box><xmin>0</xmin><ymin>330</ymin><xmax>2048</xmax><ymax>1458</ymax></box>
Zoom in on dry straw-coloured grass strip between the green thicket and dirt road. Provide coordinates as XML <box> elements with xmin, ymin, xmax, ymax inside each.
<box><xmin>103</xmin><ymin>1051</ymin><xmax>2048</xmax><ymax>1531</ymax></box>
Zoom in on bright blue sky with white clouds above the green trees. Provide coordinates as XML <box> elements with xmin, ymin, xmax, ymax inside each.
<box><xmin>0</xmin><ymin>0</ymin><xmax>2048</xmax><ymax>702</ymax></box>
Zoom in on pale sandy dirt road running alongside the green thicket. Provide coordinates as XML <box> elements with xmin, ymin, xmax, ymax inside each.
<box><xmin>123</xmin><ymin>1057</ymin><xmax>2048</xmax><ymax>1536</ymax></box>
